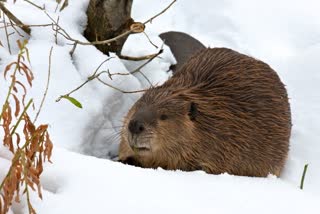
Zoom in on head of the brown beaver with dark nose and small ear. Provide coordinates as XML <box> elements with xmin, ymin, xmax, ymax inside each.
<box><xmin>120</xmin><ymin>88</ymin><xmax>197</xmax><ymax>165</ymax></box>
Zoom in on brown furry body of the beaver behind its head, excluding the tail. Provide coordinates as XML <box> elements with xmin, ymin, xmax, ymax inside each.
<box><xmin>161</xmin><ymin>48</ymin><xmax>291</xmax><ymax>176</ymax></box>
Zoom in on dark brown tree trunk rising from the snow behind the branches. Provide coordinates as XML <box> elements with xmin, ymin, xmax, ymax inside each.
<box><xmin>84</xmin><ymin>0</ymin><xmax>133</xmax><ymax>54</ymax></box>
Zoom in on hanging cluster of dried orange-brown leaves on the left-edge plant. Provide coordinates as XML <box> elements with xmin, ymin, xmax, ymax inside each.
<box><xmin>0</xmin><ymin>38</ymin><xmax>53</xmax><ymax>214</ymax></box>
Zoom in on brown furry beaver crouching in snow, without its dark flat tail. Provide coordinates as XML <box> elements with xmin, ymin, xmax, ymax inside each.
<box><xmin>119</xmin><ymin>48</ymin><xmax>291</xmax><ymax>176</ymax></box>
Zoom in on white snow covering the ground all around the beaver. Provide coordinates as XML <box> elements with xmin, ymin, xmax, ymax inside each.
<box><xmin>0</xmin><ymin>0</ymin><xmax>320</xmax><ymax>214</ymax></box>
